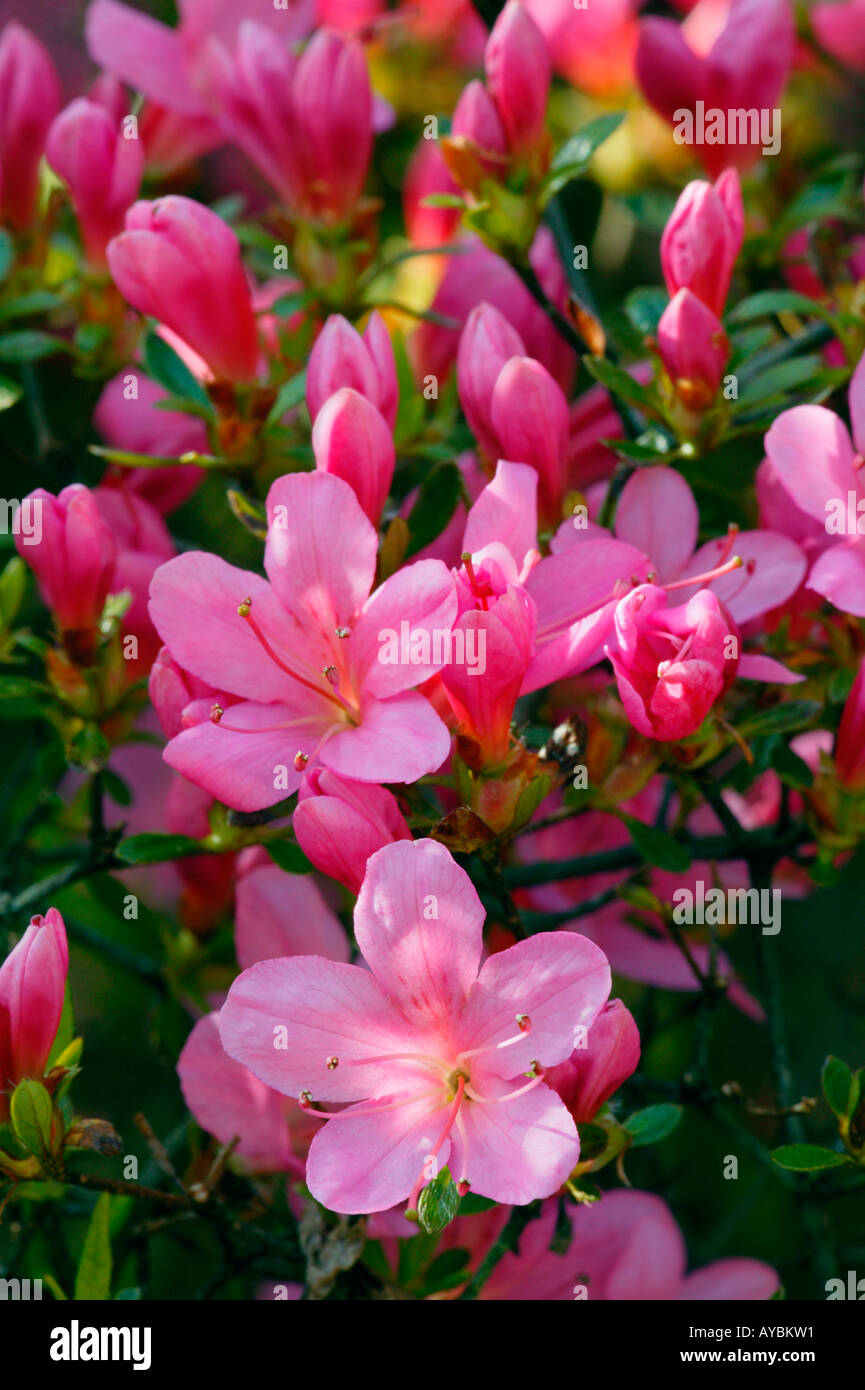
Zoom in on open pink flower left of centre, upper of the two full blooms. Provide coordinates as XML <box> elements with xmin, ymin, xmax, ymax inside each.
<box><xmin>150</xmin><ymin>473</ymin><xmax>456</xmax><ymax>810</ymax></box>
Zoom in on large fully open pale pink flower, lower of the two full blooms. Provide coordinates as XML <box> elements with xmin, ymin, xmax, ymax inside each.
<box><xmin>220</xmin><ymin>840</ymin><xmax>609</xmax><ymax>1212</ymax></box>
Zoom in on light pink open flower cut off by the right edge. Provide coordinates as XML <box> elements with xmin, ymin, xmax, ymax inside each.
<box><xmin>766</xmin><ymin>356</ymin><xmax>865</xmax><ymax>617</ymax></box>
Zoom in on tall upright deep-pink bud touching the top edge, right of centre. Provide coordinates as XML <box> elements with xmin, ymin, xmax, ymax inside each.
<box><xmin>484</xmin><ymin>0</ymin><xmax>551</xmax><ymax>154</ymax></box>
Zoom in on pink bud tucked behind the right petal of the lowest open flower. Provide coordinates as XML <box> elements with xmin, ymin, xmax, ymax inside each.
<box><xmin>547</xmin><ymin>999</ymin><xmax>640</xmax><ymax>1125</ymax></box>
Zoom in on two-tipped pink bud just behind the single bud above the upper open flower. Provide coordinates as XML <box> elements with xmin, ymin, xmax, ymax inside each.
<box><xmin>306</xmin><ymin>313</ymin><xmax>399</xmax><ymax>430</ymax></box>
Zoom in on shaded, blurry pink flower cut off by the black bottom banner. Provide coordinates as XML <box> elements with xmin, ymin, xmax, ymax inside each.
<box><xmin>478</xmin><ymin>1188</ymin><xmax>780</xmax><ymax>1302</ymax></box>
